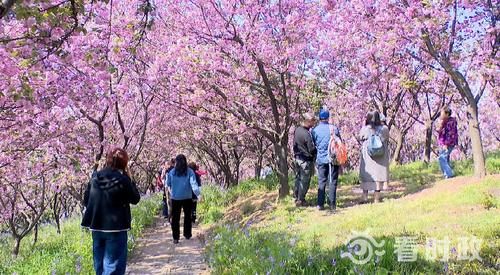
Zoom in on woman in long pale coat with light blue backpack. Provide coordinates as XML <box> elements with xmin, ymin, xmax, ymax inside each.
<box><xmin>359</xmin><ymin>112</ymin><xmax>390</xmax><ymax>202</ymax></box>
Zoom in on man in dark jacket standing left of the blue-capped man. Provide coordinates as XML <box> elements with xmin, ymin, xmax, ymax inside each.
<box><xmin>293</xmin><ymin>113</ymin><xmax>317</xmax><ymax>206</ymax></box>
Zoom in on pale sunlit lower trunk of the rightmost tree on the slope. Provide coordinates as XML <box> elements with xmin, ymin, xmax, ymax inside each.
<box><xmin>467</xmin><ymin>101</ymin><xmax>486</xmax><ymax>178</ymax></box>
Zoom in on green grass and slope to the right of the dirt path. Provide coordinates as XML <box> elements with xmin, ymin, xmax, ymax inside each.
<box><xmin>206</xmin><ymin>153</ymin><xmax>500</xmax><ymax>274</ymax></box>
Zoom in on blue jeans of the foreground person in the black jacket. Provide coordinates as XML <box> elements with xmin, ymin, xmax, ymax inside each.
<box><xmin>92</xmin><ymin>231</ymin><xmax>127</xmax><ymax>275</ymax></box>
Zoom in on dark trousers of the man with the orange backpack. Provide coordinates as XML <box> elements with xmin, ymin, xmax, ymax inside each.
<box><xmin>318</xmin><ymin>164</ymin><xmax>340</xmax><ymax>208</ymax></box>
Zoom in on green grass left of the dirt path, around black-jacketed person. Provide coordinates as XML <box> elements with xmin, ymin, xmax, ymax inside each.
<box><xmin>0</xmin><ymin>196</ymin><xmax>161</xmax><ymax>275</ymax></box>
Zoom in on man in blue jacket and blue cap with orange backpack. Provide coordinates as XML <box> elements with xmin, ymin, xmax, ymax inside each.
<box><xmin>312</xmin><ymin>108</ymin><xmax>341</xmax><ymax>210</ymax></box>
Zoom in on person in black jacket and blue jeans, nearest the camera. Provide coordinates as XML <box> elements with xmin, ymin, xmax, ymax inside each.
<box><xmin>81</xmin><ymin>148</ymin><xmax>141</xmax><ymax>275</ymax></box>
